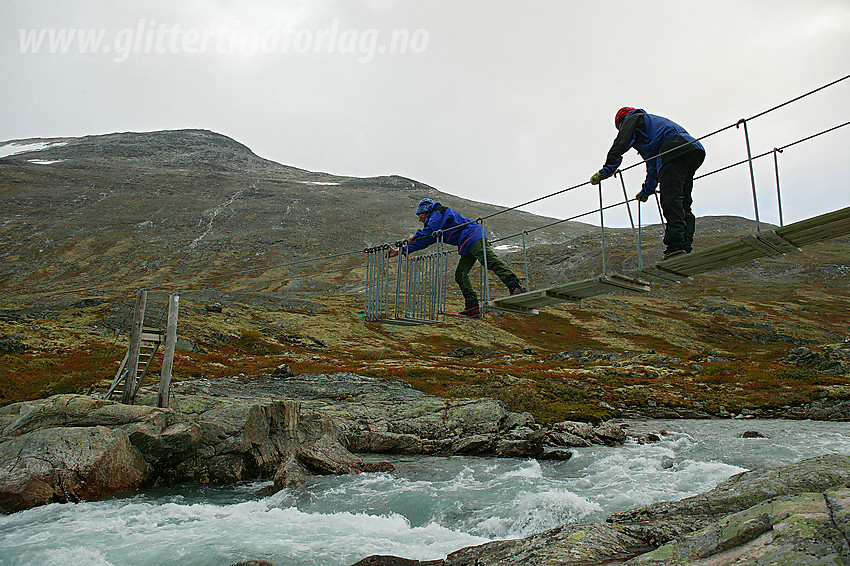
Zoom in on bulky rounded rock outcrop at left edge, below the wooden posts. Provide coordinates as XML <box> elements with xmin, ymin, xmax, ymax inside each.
<box><xmin>0</xmin><ymin>395</ymin><xmax>386</xmax><ymax>513</ymax></box>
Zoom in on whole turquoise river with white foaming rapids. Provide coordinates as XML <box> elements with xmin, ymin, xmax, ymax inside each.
<box><xmin>0</xmin><ymin>421</ymin><xmax>850</xmax><ymax>566</ymax></box>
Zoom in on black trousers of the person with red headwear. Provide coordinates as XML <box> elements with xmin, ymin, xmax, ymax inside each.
<box><xmin>658</xmin><ymin>149</ymin><xmax>705</xmax><ymax>253</ymax></box>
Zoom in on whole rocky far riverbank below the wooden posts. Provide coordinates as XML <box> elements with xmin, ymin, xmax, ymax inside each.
<box><xmin>0</xmin><ymin>373</ymin><xmax>626</xmax><ymax>513</ymax></box>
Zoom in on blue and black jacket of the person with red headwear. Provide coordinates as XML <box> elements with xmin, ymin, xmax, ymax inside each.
<box><xmin>599</xmin><ymin>108</ymin><xmax>705</xmax><ymax>194</ymax></box>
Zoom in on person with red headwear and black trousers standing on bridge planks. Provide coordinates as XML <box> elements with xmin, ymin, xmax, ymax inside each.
<box><xmin>590</xmin><ymin>106</ymin><xmax>705</xmax><ymax>259</ymax></box>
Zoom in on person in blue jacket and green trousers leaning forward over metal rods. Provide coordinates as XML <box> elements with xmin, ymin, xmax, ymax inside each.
<box><xmin>389</xmin><ymin>198</ymin><xmax>527</xmax><ymax>317</ymax></box>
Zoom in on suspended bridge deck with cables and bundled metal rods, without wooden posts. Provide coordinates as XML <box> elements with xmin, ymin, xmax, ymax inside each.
<box><xmin>364</xmin><ymin>75</ymin><xmax>850</xmax><ymax>325</ymax></box>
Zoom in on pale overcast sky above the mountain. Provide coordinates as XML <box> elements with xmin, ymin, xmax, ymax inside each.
<box><xmin>0</xmin><ymin>0</ymin><xmax>850</xmax><ymax>231</ymax></box>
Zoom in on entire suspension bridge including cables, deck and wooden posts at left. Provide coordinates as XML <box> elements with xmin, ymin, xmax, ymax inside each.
<box><xmin>33</xmin><ymin>75</ymin><xmax>850</xmax><ymax>406</ymax></box>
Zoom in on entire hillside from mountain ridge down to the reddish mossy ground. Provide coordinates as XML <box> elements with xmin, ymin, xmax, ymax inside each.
<box><xmin>0</xmin><ymin>130</ymin><xmax>850</xmax><ymax>422</ymax></box>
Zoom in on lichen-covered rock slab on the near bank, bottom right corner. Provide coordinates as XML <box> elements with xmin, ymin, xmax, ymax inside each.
<box><xmin>355</xmin><ymin>454</ymin><xmax>850</xmax><ymax>566</ymax></box>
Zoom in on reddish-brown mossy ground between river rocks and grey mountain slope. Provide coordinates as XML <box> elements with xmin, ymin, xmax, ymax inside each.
<box><xmin>0</xmin><ymin>235</ymin><xmax>850</xmax><ymax>421</ymax></box>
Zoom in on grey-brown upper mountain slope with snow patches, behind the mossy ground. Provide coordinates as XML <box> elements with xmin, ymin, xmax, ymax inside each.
<box><xmin>0</xmin><ymin>130</ymin><xmax>591</xmax><ymax>298</ymax></box>
